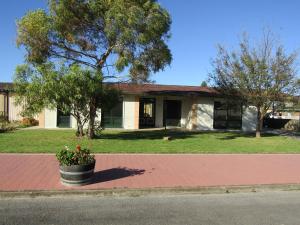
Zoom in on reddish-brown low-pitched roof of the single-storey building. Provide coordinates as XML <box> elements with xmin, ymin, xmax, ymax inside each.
<box><xmin>0</xmin><ymin>82</ymin><xmax>218</xmax><ymax>96</ymax></box>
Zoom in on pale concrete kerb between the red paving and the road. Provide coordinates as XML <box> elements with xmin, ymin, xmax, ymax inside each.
<box><xmin>0</xmin><ymin>184</ymin><xmax>300</xmax><ymax>199</ymax></box>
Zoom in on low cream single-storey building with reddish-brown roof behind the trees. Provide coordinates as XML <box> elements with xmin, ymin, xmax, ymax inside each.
<box><xmin>0</xmin><ymin>83</ymin><xmax>256</xmax><ymax>131</ymax></box>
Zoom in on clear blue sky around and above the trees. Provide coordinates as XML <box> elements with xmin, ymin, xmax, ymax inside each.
<box><xmin>0</xmin><ymin>0</ymin><xmax>300</xmax><ymax>85</ymax></box>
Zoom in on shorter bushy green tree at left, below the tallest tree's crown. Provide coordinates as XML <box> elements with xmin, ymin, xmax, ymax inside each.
<box><xmin>14</xmin><ymin>63</ymin><xmax>120</xmax><ymax>137</ymax></box>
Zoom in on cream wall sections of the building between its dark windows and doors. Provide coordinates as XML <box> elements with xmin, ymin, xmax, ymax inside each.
<box><xmin>39</xmin><ymin>95</ymin><xmax>256</xmax><ymax>131</ymax></box>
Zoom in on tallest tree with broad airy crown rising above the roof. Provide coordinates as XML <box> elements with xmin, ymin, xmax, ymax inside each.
<box><xmin>17</xmin><ymin>0</ymin><xmax>172</xmax><ymax>138</ymax></box>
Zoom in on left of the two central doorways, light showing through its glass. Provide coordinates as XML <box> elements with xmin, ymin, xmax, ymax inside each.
<box><xmin>139</xmin><ymin>98</ymin><xmax>155</xmax><ymax>128</ymax></box>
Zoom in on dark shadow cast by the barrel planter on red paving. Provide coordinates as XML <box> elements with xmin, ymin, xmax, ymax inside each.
<box><xmin>92</xmin><ymin>167</ymin><xmax>145</xmax><ymax>184</ymax></box>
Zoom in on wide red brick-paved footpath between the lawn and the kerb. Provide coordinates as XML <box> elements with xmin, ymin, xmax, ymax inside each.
<box><xmin>0</xmin><ymin>154</ymin><xmax>300</xmax><ymax>191</ymax></box>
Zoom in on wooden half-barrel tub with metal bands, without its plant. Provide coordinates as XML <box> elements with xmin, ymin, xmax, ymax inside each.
<box><xmin>59</xmin><ymin>161</ymin><xmax>96</xmax><ymax>186</ymax></box>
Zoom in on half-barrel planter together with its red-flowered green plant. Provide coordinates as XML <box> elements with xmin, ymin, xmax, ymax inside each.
<box><xmin>56</xmin><ymin>145</ymin><xmax>96</xmax><ymax>186</ymax></box>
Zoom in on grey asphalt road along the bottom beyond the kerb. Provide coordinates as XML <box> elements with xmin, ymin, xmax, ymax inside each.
<box><xmin>0</xmin><ymin>191</ymin><xmax>300</xmax><ymax>225</ymax></box>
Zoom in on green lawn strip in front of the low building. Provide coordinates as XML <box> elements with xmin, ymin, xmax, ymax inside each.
<box><xmin>0</xmin><ymin>129</ymin><xmax>300</xmax><ymax>153</ymax></box>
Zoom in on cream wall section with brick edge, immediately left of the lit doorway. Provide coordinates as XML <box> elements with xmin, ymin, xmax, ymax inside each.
<box><xmin>123</xmin><ymin>95</ymin><xmax>139</xmax><ymax>129</ymax></box>
